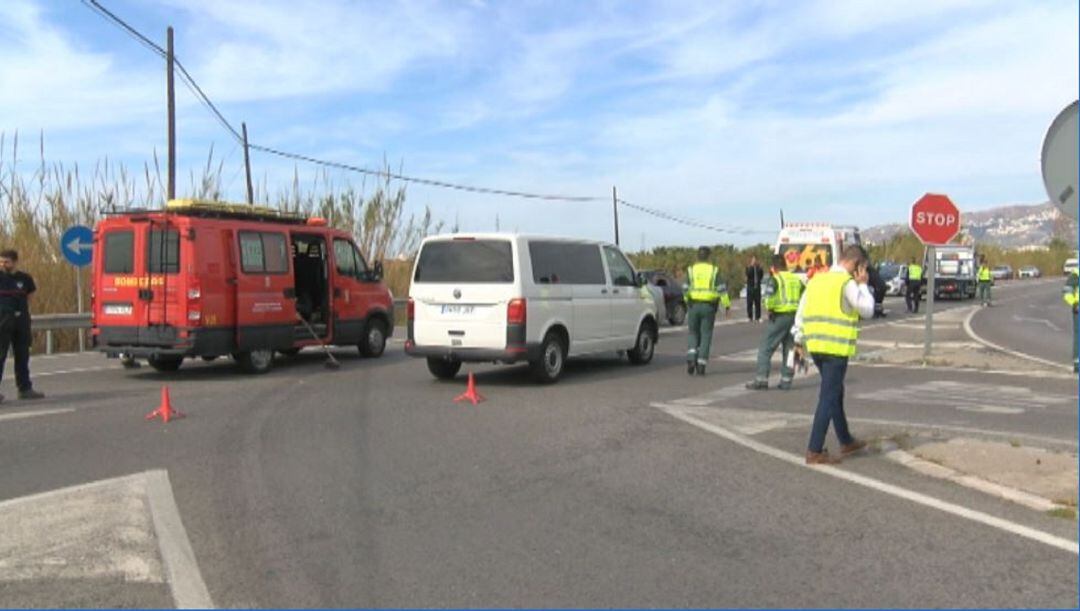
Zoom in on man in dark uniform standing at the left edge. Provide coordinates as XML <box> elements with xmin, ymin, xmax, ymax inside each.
<box><xmin>0</xmin><ymin>250</ymin><xmax>45</xmax><ymax>402</ymax></box>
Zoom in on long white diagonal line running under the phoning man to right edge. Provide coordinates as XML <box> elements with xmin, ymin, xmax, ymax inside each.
<box><xmin>653</xmin><ymin>404</ymin><xmax>1080</xmax><ymax>555</ymax></box>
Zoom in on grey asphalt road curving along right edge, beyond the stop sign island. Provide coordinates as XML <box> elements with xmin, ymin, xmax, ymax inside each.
<box><xmin>971</xmin><ymin>277</ymin><xmax>1076</xmax><ymax>366</ymax></box>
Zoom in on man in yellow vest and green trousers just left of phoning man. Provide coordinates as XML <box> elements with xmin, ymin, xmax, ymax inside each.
<box><xmin>746</xmin><ymin>255</ymin><xmax>802</xmax><ymax>391</ymax></box>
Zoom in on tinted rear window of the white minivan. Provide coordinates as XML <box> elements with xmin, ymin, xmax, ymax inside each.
<box><xmin>413</xmin><ymin>240</ymin><xmax>514</xmax><ymax>284</ymax></box>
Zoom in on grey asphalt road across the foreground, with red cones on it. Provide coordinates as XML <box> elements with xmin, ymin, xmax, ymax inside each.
<box><xmin>0</xmin><ymin>287</ymin><xmax>1078</xmax><ymax>607</ymax></box>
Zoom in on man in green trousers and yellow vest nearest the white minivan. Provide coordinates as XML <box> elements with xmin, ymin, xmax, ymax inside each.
<box><xmin>683</xmin><ymin>246</ymin><xmax>731</xmax><ymax>376</ymax></box>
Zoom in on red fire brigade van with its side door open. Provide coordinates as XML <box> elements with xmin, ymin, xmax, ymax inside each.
<box><xmin>91</xmin><ymin>200</ymin><xmax>394</xmax><ymax>374</ymax></box>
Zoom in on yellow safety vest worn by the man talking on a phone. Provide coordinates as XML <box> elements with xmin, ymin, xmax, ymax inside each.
<box><xmin>802</xmin><ymin>272</ymin><xmax>859</xmax><ymax>357</ymax></box>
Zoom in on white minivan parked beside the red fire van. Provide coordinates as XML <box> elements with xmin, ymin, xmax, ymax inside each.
<box><xmin>405</xmin><ymin>233</ymin><xmax>659</xmax><ymax>383</ymax></box>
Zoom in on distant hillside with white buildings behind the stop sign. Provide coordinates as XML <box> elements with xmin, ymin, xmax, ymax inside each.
<box><xmin>862</xmin><ymin>202</ymin><xmax>1077</xmax><ymax>248</ymax></box>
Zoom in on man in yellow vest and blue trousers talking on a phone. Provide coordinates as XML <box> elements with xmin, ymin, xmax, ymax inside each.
<box><xmin>792</xmin><ymin>246</ymin><xmax>874</xmax><ymax>464</ymax></box>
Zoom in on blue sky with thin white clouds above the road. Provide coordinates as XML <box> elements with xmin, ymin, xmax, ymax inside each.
<box><xmin>0</xmin><ymin>0</ymin><xmax>1080</xmax><ymax>249</ymax></box>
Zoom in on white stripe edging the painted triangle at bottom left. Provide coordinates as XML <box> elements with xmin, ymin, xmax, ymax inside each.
<box><xmin>145</xmin><ymin>470</ymin><xmax>214</xmax><ymax>609</ymax></box>
